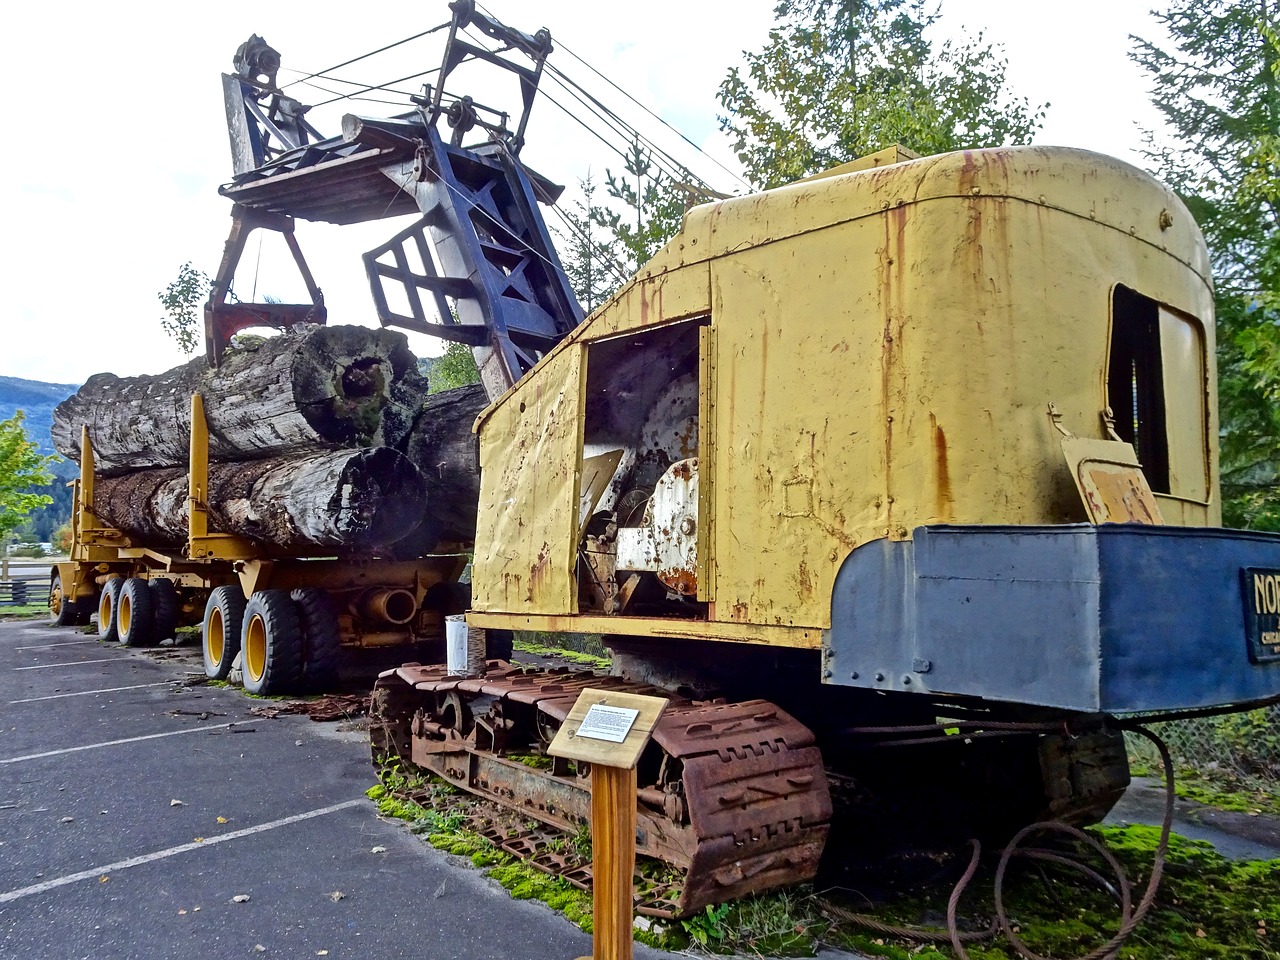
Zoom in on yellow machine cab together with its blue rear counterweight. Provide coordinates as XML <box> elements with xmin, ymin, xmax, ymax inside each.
<box><xmin>470</xmin><ymin>147</ymin><xmax>1280</xmax><ymax>712</ymax></box>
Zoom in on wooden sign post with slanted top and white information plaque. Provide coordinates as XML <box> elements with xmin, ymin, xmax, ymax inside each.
<box><xmin>547</xmin><ymin>687</ymin><xmax>667</xmax><ymax>960</ymax></box>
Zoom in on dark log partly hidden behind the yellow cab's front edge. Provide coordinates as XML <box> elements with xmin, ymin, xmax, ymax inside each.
<box><xmin>402</xmin><ymin>384</ymin><xmax>489</xmax><ymax>552</ymax></box>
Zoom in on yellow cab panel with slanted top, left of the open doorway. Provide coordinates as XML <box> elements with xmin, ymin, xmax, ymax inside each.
<box><xmin>471</xmin><ymin>346</ymin><xmax>586</xmax><ymax>614</ymax></box>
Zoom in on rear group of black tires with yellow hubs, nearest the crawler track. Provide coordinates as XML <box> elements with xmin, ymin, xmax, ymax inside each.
<box><xmin>204</xmin><ymin>586</ymin><xmax>342</xmax><ymax>695</ymax></box>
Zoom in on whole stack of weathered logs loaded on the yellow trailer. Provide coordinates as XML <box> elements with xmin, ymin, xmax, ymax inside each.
<box><xmin>52</xmin><ymin>325</ymin><xmax>488</xmax><ymax>558</ymax></box>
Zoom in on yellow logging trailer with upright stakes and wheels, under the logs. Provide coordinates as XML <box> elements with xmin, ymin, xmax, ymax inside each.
<box><xmin>49</xmin><ymin>394</ymin><xmax>467</xmax><ymax>694</ymax></box>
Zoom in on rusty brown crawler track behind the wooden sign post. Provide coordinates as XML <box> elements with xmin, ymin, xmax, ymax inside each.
<box><xmin>370</xmin><ymin>662</ymin><xmax>831</xmax><ymax>916</ymax></box>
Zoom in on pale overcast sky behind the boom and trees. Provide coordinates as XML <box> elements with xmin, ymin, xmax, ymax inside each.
<box><xmin>0</xmin><ymin>0</ymin><xmax>1158</xmax><ymax>383</ymax></box>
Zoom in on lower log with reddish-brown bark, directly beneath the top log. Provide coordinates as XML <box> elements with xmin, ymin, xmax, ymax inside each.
<box><xmin>93</xmin><ymin>447</ymin><xmax>426</xmax><ymax>556</ymax></box>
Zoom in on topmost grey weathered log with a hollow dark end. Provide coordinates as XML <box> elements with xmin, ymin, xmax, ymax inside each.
<box><xmin>51</xmin><ymin>325</ymin><xmax>426</xmax><ymax>475</ymax></box>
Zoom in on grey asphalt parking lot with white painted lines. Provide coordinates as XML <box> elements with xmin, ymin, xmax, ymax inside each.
<box><xmin>0</xmin><ymin>622</ymin><xmax>686</xmax><ymax>960</ymax></box>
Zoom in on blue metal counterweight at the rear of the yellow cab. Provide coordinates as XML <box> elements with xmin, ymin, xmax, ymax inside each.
<box><xmin>824</xmin><ymin>525</ymin><xmax>1280</xmax><ymax>713</ymax></box>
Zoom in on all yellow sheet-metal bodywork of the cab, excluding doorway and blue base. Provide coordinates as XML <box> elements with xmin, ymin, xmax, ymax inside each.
<box><xmin>474</xmin><ymin>147</ymin><xmax>1220</xmax><ymax>646</ymax></box>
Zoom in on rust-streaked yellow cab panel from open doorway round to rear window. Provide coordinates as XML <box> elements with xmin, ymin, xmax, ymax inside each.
<box><xmin>711</xmin><ymin>150</ymin><xmax>1216</xmax><ymax>627</ymax></box>
